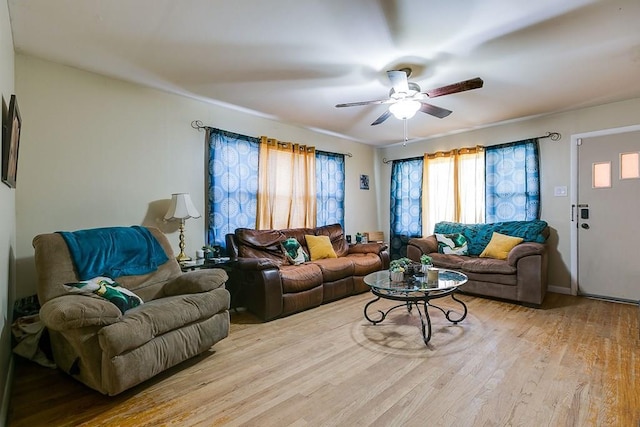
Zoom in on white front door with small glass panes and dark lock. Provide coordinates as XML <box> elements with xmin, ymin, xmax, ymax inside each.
<box><xmin>574</xmin><ymin>130</ymin><xmax>640</xmax><ymax>302</ymax></box>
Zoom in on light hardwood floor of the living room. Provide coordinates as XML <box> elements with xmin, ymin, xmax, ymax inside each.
<box><xmin>9</xmin><ymin>294</ymin><xmax>640</xmax><ymax>427</ymax></box>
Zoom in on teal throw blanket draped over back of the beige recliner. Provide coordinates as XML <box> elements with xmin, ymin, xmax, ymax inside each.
<box><xmin>58</xmin><ymin>225</ymin><xmax>169</xmax><ymax>280</ymax></box>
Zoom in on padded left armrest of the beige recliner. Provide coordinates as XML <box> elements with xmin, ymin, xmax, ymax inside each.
<box><xmin>40</xmin><ymin>295</ymin><xmax>122</xmax><ymax>332</ymax></box>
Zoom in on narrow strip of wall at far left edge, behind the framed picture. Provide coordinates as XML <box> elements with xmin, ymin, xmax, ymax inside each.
<box><xmin>0</xmin><ymin>0</ymin><xmax>16</xmax><ymax>418</ymax></box>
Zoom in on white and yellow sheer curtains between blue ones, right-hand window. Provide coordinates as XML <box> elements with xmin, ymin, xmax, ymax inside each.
<box><xmin>422</xmin><ymin>146</ymin><xmax>484</xmax><ymax>236</ymax></box>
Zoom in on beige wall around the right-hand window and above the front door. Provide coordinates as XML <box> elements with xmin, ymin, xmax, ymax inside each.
<box><xmin>375</xmin><ymin>99</ymin><xmax>640</xmax><ymax>292</ymax></box>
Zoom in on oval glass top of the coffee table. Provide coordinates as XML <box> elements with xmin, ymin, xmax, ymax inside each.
<box><xmin>364</xmin><ymin>268</ymin><xmax>467</xmax><ymax>293</ymax></box>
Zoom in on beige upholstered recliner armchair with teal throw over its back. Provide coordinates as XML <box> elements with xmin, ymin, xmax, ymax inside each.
<box><xmin>33</xmin><ymin>227</ymin><xmax>230</xmax><ymax>396</ymax></box>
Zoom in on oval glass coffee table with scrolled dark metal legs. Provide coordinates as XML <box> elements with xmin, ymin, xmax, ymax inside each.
<box><xmin>364</xmin><ymin>268</ymin><xmax>467</xmax><ymax>344</ymax></box>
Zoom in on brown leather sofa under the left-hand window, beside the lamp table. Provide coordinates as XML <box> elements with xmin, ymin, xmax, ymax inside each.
<box><xmin>226</xmin><ymin>224</ymin><xmax>389</xmax><ymax>320</ymax></box>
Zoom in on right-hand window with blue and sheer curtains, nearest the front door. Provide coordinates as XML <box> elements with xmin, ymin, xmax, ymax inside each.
<box><xmin>390</xmin><ymin>139</ymin><xmax>540</xmax><ymax>244</ymax></box>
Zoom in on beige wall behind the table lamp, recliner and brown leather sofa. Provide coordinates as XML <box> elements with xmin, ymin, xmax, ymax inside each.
<box><xmin>16</xmin><ymin>55</ymin><xmax>378</xmax><ymax>296</ymax></box>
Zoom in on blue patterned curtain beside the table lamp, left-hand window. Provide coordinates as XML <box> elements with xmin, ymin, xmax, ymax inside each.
<box><xmin>207</xmin><ymin>129</ymin><xmax>260</xmax><ymax>248</ymax></box>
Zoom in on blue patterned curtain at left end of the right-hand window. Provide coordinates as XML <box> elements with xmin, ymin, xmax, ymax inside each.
<box><xmin>389</xmin><ymin>157</ymin><xmax>424</xmax><ymax>259</ymax></box>
